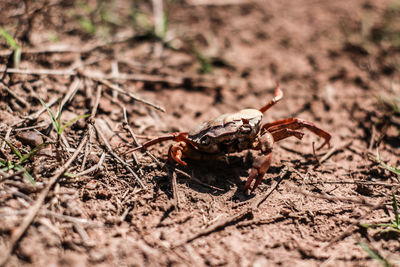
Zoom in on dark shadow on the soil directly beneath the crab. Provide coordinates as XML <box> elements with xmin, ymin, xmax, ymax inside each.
<box><xmin>155</xmin><ymin>153</ymin><xmax>281</xmax><ymax>202</ymax></box>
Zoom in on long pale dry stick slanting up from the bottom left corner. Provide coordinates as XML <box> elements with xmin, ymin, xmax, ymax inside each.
<box><xmin>0</xmin><ymin>135</ymin><xmax>88</xmax><ymax>266</ymax></box>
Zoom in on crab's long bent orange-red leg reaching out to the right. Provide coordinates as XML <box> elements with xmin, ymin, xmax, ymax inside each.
<box><xmin>262</xmin><ymin>118</ymin><xmax>331</xmax><ymax>149</ymax></box>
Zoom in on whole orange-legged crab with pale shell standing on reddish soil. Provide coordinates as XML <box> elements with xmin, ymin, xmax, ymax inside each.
<box><xmin>125</xmin><ymin>83</ymin><xmax>331</xmax><ymax>192</ymax></box>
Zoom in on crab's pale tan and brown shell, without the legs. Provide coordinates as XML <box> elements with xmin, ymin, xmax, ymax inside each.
<box><xmin>188</xmin><ymin>109</ymin><xmax>263</xmax><ymax>153</ymax></box>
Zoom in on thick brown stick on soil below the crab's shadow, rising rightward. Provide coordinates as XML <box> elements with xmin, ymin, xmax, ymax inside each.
<box><xmin>173</xmin><ymin>208</ymin><xmax>253</xmax><ymax>248</ymax></box>
